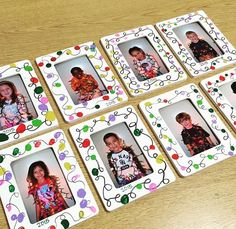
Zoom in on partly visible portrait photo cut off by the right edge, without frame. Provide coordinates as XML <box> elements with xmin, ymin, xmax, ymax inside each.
<box><xmin>219</xmin><ymin>80</ymin><xmax>236</xmax><ymax>109</ymax></box>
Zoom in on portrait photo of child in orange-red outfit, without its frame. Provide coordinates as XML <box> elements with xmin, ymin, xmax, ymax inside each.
<box><xmin>55</xmin><ymin>55</ymin><xmax>108</xmax><ymax>105</ymax></box>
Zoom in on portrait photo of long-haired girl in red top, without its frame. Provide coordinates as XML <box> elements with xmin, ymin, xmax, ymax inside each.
<box><xmin>11</xmin><ymin>148</ymin><xmax>75</xmax><ymax>224</ymax></box>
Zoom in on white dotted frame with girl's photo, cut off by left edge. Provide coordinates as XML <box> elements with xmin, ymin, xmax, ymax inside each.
<box><xmin>0</xmin><ymin>60</ymin><xmax>58</xmax><ymax>146</ymax></box>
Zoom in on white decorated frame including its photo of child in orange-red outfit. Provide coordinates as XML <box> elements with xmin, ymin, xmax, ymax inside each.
<box><xmin>36</xmin><ymin>42</ymin><xmax>127</xmax><ymax>122</ymax></box>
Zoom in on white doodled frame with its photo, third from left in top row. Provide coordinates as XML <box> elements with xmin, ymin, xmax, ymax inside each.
<box><xmin>101</xmin><ymin>25</ymin><xmax>187</xmax><ymax>96</ymax></box>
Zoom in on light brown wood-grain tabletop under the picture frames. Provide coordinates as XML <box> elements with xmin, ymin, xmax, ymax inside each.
<box><xmin>0</xmin><ymin>0</ymin><xmax>236</xmax><ymax>229</ymax></box>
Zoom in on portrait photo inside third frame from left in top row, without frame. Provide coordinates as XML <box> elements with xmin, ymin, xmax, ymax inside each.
<box><xmin>118</xmin><ymin>37</ymin><xmax>169</xmax><ymax>81</ymax></box>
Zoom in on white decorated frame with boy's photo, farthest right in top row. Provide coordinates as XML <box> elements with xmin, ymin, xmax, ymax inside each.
<box><xmin>156</xmin><ymin>10</ymin><xmax>236</xmax><ymax>77</ymax></box>
